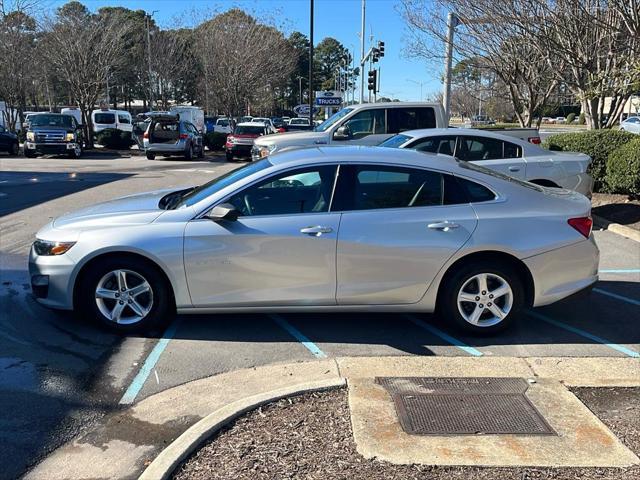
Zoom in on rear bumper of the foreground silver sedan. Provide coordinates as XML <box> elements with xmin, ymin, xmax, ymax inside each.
<box><xmin>523</xmin><ymin>235</ymin><xmax>600</xmax><ymax>307</ymax></box>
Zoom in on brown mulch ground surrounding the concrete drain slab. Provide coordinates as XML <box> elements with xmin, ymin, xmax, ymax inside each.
<box><xmin>173</xmin><ymin>388</ymin><xmax>640</xmax><ymax>480</ymax></box>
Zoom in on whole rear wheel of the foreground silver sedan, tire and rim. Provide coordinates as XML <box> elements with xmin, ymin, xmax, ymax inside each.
<box><xmin>439</xmin><ymin>262</ymin><xmax>524</xmax><ymax>334</ymax></box>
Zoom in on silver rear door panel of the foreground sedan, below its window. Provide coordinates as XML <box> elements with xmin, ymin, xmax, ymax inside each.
<box><xmin>336</xmin><ymin>204</ymin><xmax>477</xmax><ymax>305</ymax></box>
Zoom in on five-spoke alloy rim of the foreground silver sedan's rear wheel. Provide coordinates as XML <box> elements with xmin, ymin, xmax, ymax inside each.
<box><xmin>457</xmin><ymin>273</ymin><xmax>513</xmax><ymax>327</ymax></box>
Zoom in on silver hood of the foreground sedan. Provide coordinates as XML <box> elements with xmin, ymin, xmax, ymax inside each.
<box><xmin>53</xmin><ymin>188</ymin><xmax>178</xmax><ymax>230</ymax></box>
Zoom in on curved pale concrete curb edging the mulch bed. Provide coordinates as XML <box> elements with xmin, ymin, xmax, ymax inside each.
<box><xmin>139</xmin><ymin>378</ymin><xmax>346</xmax><ymax>480</ymax></box>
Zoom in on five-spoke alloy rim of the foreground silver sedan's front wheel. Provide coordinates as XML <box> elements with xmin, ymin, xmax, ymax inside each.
<box><xmin>95</xmin><ymin>269</ymin><xmax>153</xmax><ymax>325</ymax></box>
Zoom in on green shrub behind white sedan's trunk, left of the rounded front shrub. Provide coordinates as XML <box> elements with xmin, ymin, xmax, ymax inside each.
<box><xmin>542</xmin><ymin>130</ymin><xmax>635</xmax><ymax>192</ymax></box>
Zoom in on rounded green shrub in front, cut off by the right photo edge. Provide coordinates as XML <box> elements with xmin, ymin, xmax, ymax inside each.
<box><xmin>607</xmin><ymin>137</ymin><xmax>640</xmax><ymax>196</ymax></box>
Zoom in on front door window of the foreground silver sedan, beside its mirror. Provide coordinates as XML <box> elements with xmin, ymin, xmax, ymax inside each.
<box><xmin>228</xmin><ymin>165</ymin><xmax>336</xmax><ymax>217</ymax></box>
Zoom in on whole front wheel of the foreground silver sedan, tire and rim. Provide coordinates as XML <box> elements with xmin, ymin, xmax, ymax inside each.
<box><xmin>78</xmin><ymin>258</ymin><xmax>174</xmax><ymax>332</ymax></box>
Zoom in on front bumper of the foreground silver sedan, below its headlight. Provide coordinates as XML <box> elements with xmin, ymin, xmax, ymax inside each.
<box><xmin>29</xmin><ymin>247</ymin><xmax>76</xmax><ymax>310</ymax></box>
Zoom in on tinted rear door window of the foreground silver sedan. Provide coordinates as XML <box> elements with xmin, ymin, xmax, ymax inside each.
<box><xmin>336</xmin><ymin>165</ymin><xmax>443</xmax><ymax>210</ymax></box>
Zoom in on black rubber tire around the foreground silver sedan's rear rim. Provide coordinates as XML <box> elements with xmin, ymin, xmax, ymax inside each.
<box><xmin>438</xmin><ymin>261</ymin><xmax>525</xmax><ymax>335</ymax></box>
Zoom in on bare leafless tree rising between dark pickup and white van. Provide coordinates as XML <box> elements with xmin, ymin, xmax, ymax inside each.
<box><xmin>42</xmin><ymin>2</ymin><xmax>131</xmax><ymax>147</ymax></box>
